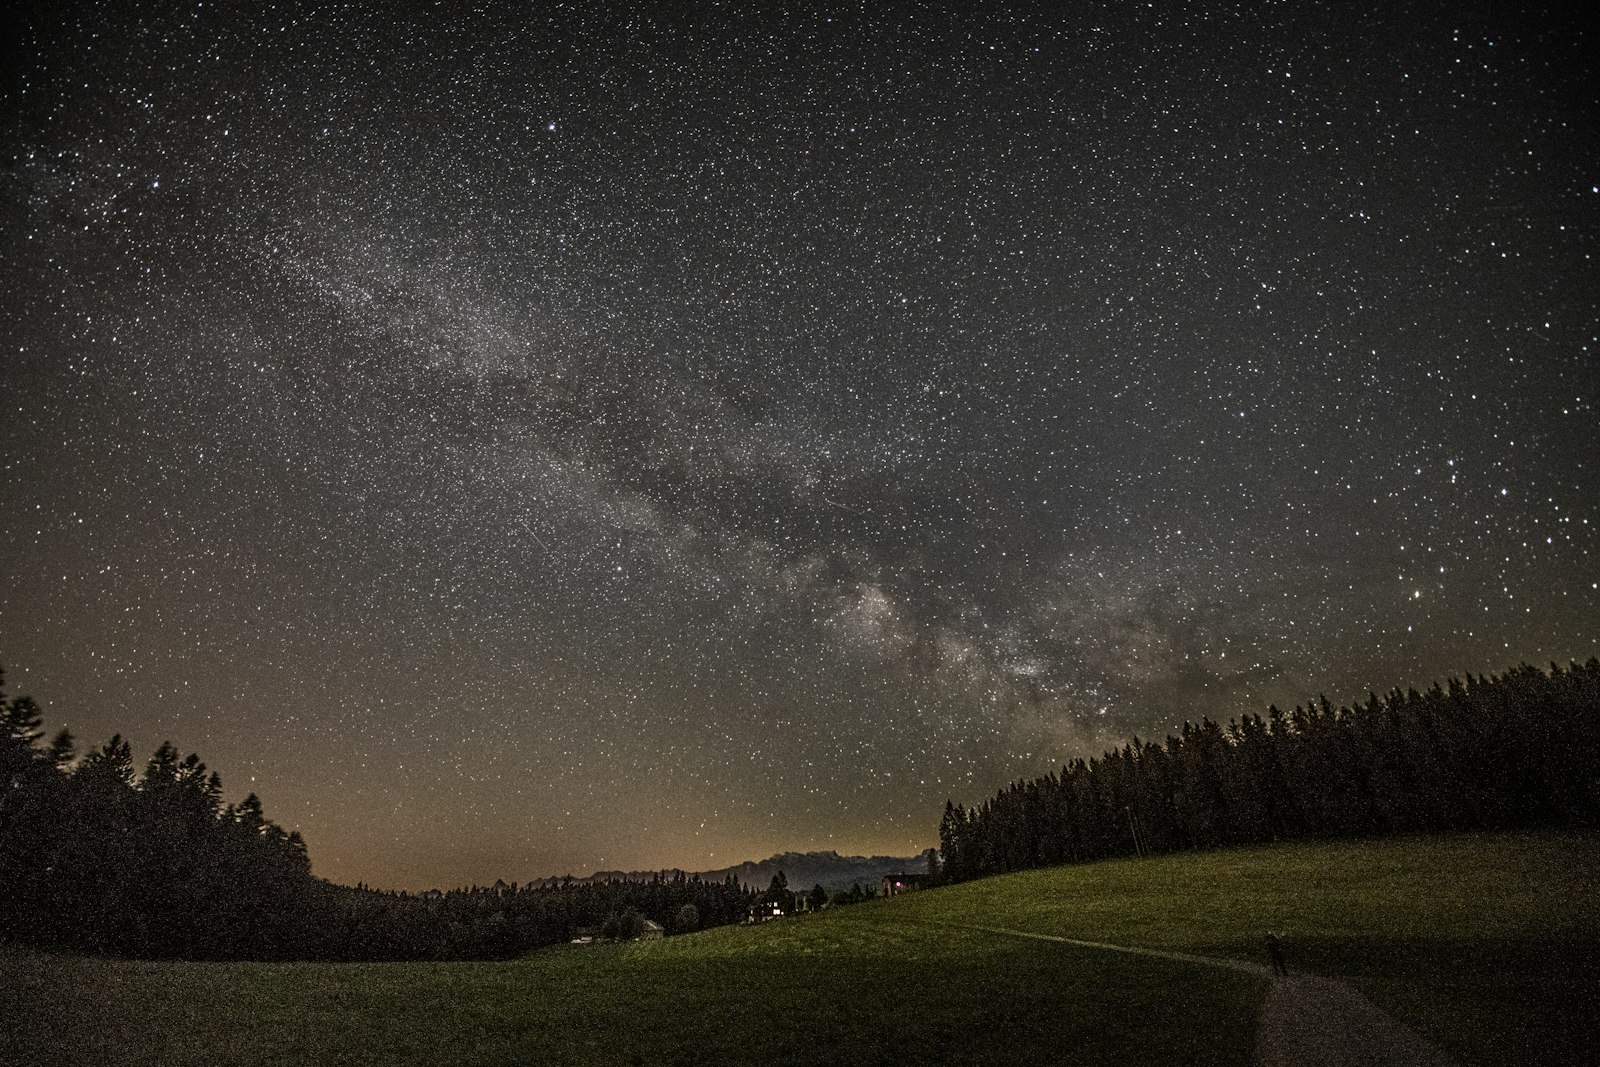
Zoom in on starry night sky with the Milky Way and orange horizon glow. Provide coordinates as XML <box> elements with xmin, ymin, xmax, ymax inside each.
<box><xmin>0</xmin><ymin>0</ymin><xmax>1600</xmax><ymax>888</ymax></box>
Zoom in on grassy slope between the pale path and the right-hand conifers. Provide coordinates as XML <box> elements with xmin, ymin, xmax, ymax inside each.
<box><xmin>898</xmin><ymin>833</ymin><xmax>1600</xmax><ymax>1064</ymax></box>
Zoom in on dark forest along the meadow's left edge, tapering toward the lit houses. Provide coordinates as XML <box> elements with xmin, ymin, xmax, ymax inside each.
<box><xmin>0</xmin><ymin>672</ymin><xmax>758</xmax><ymax>960</ymax></box>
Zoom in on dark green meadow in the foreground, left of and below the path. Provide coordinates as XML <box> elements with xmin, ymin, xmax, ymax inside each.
<box><xmin>8</xmin><ymin>904</ymin><xmax>1261</xmax><ymax>1065</ymax></box>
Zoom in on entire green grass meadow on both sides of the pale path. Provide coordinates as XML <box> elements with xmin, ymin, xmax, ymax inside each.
<box><xmin>0</xmin><ymin>835</ymin><xmax>1600</xmax><ymax>1064</ymax></box>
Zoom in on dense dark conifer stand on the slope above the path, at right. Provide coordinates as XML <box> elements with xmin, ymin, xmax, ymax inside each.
<box><xmin>938</xmin><ymin>657</ymin><xmax>1600</xmax><ymax>881</ymax></box>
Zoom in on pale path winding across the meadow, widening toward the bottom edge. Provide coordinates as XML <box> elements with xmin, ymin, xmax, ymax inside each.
<box><xmin>940</xmin><ymin>923</ymin><xmax>1456</xmax><ymax>1067</ymax></box>
